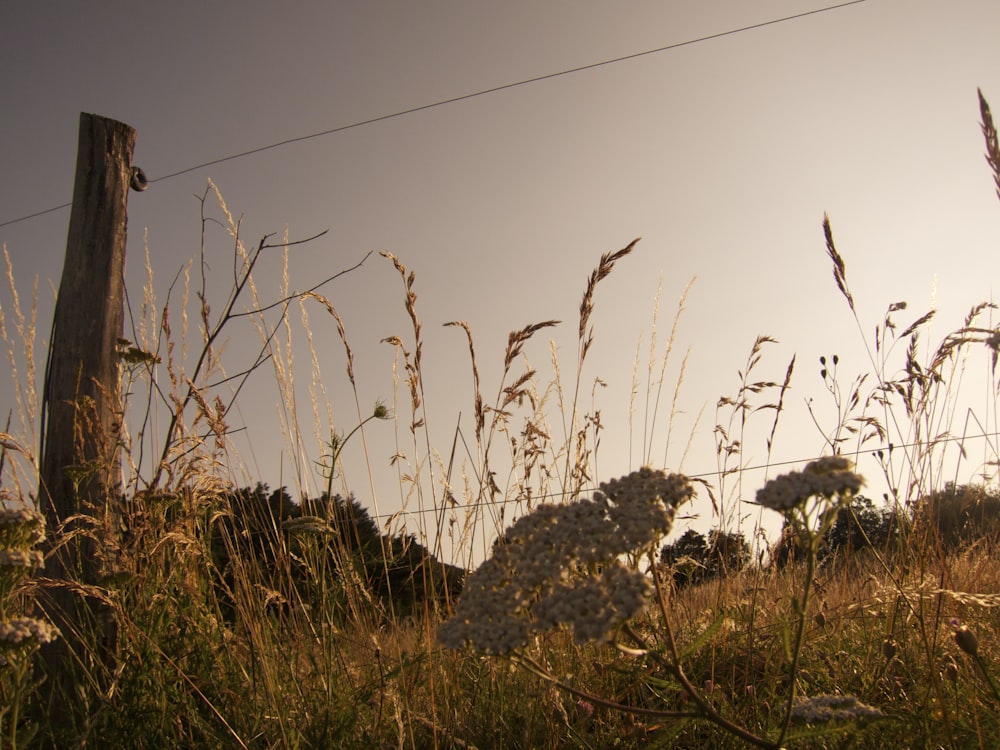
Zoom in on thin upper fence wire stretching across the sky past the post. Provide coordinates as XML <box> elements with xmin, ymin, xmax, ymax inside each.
<box><xmin>0</xmin><ymin>0</ymin><xmax>867</xmax><ymax>227</ymax></box>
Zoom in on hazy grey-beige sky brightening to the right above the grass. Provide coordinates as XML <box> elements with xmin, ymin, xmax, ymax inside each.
<box><xmin>0</xmin><ymin>0</ymin><xmax>1000</xmax><ymax>564</ymax></box>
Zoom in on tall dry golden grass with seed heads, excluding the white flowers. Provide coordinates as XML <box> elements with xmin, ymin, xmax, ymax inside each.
<box><xmin>0</xmin><ymin>98</ymin><xmax>1000</xmax><ymax>748</ymax></box>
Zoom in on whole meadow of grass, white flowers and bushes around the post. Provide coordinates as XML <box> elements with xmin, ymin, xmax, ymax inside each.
<box><xmin>0</xmin><ymin>98</ymin><xmax>1000</xmax><ymax>749</ymax></box>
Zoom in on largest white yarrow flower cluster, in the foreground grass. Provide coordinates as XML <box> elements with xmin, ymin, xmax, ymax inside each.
<box><xmin>438</xmin><ymin>468</ymin><xmax>694</xmax><ymax>654</ymax></box>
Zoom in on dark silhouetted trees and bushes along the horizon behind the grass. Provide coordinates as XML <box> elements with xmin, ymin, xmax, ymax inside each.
<box><xmin>209</xmin><ymin>483</ymin><xmax>1000</xmax><ymax>616</ymax></box>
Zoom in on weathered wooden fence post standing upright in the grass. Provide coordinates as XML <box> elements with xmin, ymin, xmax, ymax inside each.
<box><xmin>38</xmin><ymin>113</ymin><xmax>136</xmax><ymax>740</ymax></box>
